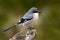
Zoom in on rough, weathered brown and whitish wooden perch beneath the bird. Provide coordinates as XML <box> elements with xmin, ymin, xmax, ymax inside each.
<box><xmin>9</xmin><ymin>28</ymin><xmax>37</xmax><ymax>40</ymax></box>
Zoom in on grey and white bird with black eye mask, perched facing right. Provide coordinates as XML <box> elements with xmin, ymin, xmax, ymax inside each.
<box><xmin>4</xmin><ymin>7</ymin><xmax>41</xmax><ymax>32</ymax></box>
